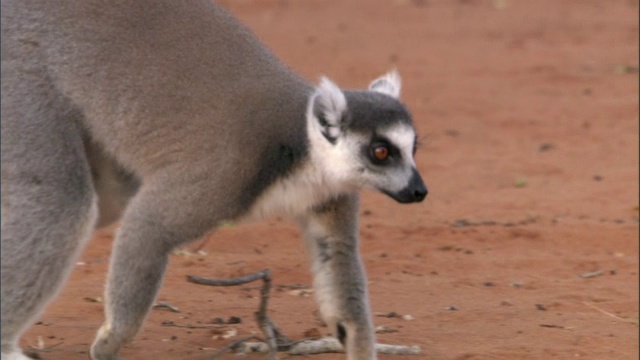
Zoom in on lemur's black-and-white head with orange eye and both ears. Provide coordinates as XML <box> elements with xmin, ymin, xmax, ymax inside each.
<box><xmin>307</xmin><ymin>71</ymin><xmax>427</xmax><ymax>203</ymax></box>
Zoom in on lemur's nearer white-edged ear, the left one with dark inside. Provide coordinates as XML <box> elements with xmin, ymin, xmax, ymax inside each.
<box><xmin>311</xmin><ymin>77</ymin><xmax>347</xmax><ymax>144</ymax></box>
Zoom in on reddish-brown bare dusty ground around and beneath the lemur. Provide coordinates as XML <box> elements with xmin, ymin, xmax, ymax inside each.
<box><xmin>18</xmin><ymin>0</ymin><xmax>639</xmax><ymax>359</ymax></box>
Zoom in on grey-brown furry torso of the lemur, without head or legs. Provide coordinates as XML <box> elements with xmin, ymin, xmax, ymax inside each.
<box><xmin>3</xmin><ymin>0</ymin><xmax>313</xmax><ymax>217</ymax></box>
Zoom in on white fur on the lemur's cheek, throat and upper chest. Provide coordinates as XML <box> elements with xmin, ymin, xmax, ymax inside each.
<box><xmin>239</xmin><ymin>122</ymin><xmax>415</xmax><ymax>221</ymax></box>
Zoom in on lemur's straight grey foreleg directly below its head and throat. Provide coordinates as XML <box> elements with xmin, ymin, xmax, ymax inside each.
<box><xmin>299</xmin><ymin>194</ymin><xmax>376</xmax><ymax>360</ymax></box>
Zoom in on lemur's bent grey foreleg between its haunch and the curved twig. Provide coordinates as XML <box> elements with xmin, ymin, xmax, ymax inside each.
<box><xmin>91</xmin><ymin>178</ymin><xmax>238</xmax><ymax>360</ymax></box>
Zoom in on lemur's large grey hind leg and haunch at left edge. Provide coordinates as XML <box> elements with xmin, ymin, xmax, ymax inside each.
<box><xmin>0</xmin><ymin>74</ymin><xmax>97</xmax><ymax>359</ymax></box>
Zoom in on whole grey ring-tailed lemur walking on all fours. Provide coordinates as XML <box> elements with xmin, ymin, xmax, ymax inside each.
<box><xmin>1</xmin><ymin>0</ymin><xmax>427</xmax><ymax>360</ymax></box>
